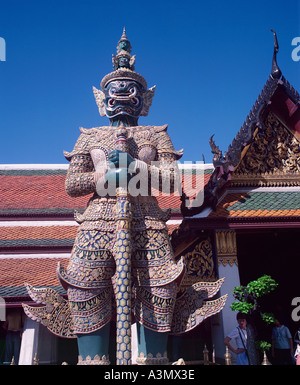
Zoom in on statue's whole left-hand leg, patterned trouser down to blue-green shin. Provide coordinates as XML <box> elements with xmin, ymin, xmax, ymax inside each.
<box><xmin>58</xmin><ymin>230</ymin><xmax>115</xmax><ymax>365</ymax></box>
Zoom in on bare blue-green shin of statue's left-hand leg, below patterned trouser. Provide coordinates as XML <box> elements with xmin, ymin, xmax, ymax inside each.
<box><xmin>77</xmin><ymin>323</ymin><xmax>110</xmax><ymax>365</ymax></box>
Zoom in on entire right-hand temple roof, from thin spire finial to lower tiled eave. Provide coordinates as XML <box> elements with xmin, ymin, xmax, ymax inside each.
<box><xmin>172</xmin><ymin>33</ymin><xmax>300</xmax><ymax>255</ymax></box>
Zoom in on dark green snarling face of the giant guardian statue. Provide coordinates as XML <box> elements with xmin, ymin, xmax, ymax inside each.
<box><xmin>103</xmin><ymin>80</ymin><xmax>144</xmax><ymax>118</ymax></box>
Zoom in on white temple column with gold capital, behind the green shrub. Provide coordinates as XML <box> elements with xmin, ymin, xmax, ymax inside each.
<box><xmin>212</xmin><ymin>230</ymin><xmax>240</xmax><ymax>360</ymax></box>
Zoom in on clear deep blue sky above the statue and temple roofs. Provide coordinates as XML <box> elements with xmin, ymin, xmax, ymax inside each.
<box><xmin>0</xmin><ymin>0</ymin><xmax>300</xmax><ymax>164</ymax></box>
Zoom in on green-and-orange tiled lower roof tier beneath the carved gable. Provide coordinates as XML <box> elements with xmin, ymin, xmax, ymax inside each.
<box><xmin>172</xmin><ymin>186</ymin><xmax>300</xmax><ymax>240</ymax></box>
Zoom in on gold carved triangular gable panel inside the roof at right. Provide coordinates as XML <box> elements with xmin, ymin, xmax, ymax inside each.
<box><xmin>231</xmin><ymin>112</ymin><xmax>300</xmax><ymax>186</ymax></box>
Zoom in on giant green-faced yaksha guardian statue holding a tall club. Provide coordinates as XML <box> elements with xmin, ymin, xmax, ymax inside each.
<box><xmin>24</xmin><ymin>29</ymin><xmax>225</xmax><ymax>364</ymax></box>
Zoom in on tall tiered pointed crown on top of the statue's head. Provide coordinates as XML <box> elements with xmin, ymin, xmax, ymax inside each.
<box><xmin>101</xmin><ymin>28</ymin><xmax>147</xmax><ymax>90</ymax></box>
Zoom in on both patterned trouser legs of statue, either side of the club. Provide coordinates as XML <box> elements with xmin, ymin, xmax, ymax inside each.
<box><xmin>58</xmin><ymin>229</ymin><xmax>184</xmax><ymax>333</ymax></box>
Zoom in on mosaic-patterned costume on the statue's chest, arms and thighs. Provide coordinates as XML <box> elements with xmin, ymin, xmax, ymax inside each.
<box><xmin>58</xmin><ymin>126</ymin><xmax>184</xmax><ymax>333</ymax></box>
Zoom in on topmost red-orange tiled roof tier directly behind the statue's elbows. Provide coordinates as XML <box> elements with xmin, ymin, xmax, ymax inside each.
<box><xmin>0</xmin><ymin>164</ymin><xmax>213</xmax><ymax>220</ymax></box>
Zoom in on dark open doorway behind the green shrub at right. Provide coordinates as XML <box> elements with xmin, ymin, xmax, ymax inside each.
<box><xmin>237</xmin><ymin>229</ymin><xmax>300</xmax><ymax>335</ymax></box>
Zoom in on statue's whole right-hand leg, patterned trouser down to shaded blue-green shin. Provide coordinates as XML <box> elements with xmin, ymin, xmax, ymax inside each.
<box><xmin>133</xmin><ymin>229</ymin><xmax>184</xmax><ymax>365</ymax></box>
